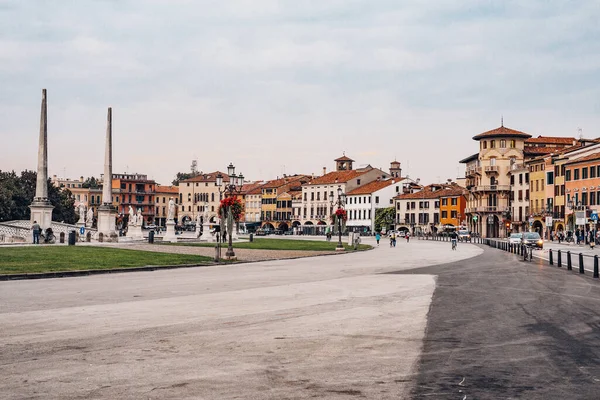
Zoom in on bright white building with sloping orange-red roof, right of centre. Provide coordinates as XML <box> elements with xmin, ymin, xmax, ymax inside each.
<box><xmin>346</xmin><ymin>178</ymin><xmax>403</xmax><ymax>232</ymax></box>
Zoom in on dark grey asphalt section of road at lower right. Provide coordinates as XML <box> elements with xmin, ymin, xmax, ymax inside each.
<box><xmin>400</xmin><ymin>248</ymin><xmax>600</xmax><ymax>400</ymax></box>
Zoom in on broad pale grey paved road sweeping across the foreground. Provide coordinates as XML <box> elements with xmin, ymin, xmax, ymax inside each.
<box><xmin>0</xmin><ymin>241</ymin><xmax>481</xmax><ymax>400</ymax></box>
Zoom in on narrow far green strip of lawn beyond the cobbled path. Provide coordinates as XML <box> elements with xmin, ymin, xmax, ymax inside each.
<box><xmin>164</xmin><ymin>237</ymin><xmax>371</xmax><ymax>251</ymax></box>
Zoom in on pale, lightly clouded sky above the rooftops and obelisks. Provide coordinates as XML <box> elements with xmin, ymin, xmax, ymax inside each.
<box><xmin>0</xmin><ymin>0</ymin><xmax>600</xmax><ymax>184</ymax></box>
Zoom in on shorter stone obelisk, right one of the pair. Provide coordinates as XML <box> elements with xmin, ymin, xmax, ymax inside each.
<box><xmin>98</xmin><ymin>107</ymin><xmax>117</xmax><ymax>241</ymax></box>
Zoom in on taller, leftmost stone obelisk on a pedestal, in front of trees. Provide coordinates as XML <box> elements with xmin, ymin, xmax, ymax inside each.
<box><xmin>29</xmin><ymin>89</ymin><xmax>54</xmax><ymax>229</ymax></box>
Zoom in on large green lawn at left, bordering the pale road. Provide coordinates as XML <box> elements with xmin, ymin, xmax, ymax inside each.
<box><xmin>0</xmin><ymin>246</ymin><xmax>212</xmax><ymax>274</ymax></box>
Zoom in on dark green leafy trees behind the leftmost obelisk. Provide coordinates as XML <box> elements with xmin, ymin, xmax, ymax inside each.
<box><xmin>0</xmin><ymin>170</ymin><xmax>77</xmax><ymax>224</ymax></box>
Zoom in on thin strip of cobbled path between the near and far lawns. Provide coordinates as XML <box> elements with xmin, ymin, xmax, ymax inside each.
<box><xmin>118</xmin><ymin>244</ymin><xmax>336</xmax><ymax>261</ymax></box>
